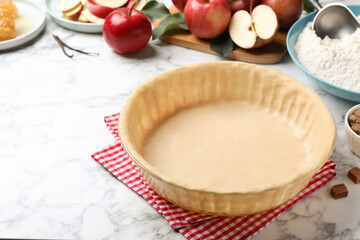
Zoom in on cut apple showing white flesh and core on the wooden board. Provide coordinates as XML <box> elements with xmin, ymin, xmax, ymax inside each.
<box><xmin>229</xmin><ymin>5</ymin><xmax>279</xmax><ymax>49</ymax></box>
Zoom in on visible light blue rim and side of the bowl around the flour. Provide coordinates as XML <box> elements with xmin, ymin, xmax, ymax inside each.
<box><xmin>286</xmin><ymin>5</ymin><xmax>360</xmax><ymax>102</ymax></box>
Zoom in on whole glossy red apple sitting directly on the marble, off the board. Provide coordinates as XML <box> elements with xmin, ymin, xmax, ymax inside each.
<box><xmin>103</xmin><ymin>8</ymin><xmax>152</xmax><ymax>54</ymax></box>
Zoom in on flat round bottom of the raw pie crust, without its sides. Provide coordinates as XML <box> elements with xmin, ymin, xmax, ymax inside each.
<box><xmin>143</xmin><ymin>101</ymin><xmax>309</xmax><ymax>192</ymax></box>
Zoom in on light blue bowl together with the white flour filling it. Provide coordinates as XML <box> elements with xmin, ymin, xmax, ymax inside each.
<box><xmin>287</xmin><ymin>5</ymin><xmax>360</xmax><ymax>102</ymax></box>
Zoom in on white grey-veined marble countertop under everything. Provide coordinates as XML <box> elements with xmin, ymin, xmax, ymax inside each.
<box><xmin>0</xmin><ymin>0</ymin><xmax>360</xmax><ymax>240</ymax></box>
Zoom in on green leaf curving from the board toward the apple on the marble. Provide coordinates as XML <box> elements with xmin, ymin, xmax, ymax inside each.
<box><xmin>152</xmin><ymin>13</ymin><xmax>189</xmax><ymax>40</ymax></box>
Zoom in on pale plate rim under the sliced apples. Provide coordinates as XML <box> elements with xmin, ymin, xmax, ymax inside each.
<box><xmin>45</xmin><ymin>0</ymin><xmax>103</xmax><ymax>33</ymax></box>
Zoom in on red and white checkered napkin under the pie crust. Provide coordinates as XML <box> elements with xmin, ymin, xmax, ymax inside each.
<box><xmin>92</xmin><ymin>114</ymin><xmax>336</xmax><ymax>240</ymax></box>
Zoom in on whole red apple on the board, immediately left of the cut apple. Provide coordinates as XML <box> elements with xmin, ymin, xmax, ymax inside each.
<box><xmin>184</xmin><ymin>0</ymin><xmax>231</xmax><ymax>39</ymax></box>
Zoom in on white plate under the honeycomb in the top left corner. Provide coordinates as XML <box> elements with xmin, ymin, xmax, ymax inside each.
<box><xmin>0</xmin><ymin>0</ymin><xmax>45</xmax><ymax>51</ymax></box>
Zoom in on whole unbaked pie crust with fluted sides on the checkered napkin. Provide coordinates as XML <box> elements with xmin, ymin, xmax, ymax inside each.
<box><xmin>119</xmin><ymin>62</ymin><xmax>336</xmax><ymax>216</ymax></box>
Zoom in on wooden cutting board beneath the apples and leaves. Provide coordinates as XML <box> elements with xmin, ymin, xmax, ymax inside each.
<box><xmin>154</xmin><ymin>6</ymin><xmax>287</xmax><ymax>64</ymax></box>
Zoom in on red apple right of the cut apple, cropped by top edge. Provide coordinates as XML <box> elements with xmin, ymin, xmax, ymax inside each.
<box><xmin>262</xmin><ymin>0</ymin><xmax>303</xmax><ymax>29</ymax></box>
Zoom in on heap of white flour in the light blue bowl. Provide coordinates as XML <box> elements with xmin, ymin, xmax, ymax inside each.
<box><xmin>295</xmin><ymin>23</ymin><xmax>360</xmax><ymax>92</ymax></box>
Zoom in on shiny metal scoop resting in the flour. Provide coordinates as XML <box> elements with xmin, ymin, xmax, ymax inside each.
<box><xmin>308</xmin><ymin>0</ymin><xmax>360</xmax><ymax>39</ymax></box>
